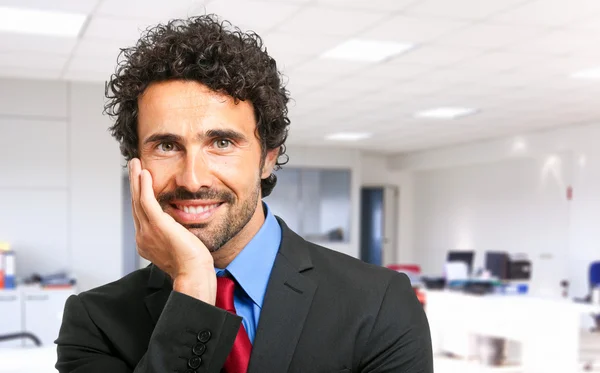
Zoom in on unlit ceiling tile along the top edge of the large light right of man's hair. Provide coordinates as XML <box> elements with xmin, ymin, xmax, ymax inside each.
<box><xmin>361</xmin><ymin>16</ymin><xmax>469</xmax><ymax>44</ymax></box>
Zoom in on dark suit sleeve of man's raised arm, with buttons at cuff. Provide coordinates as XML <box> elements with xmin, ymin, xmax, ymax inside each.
<box><xmin>56</xmin><ymin>291</ymin><xmax>241</xmax><ymax>373</ymax></box>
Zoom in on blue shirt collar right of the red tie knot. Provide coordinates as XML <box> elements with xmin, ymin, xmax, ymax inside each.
<box><xmin>217</xmin><ymin>202</ymin><xmax>281</xmax><ymax>308</ymax></box>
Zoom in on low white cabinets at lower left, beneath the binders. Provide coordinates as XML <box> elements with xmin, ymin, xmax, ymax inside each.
<box><xmin>0</xmin><ymin>287</ymin><xmax>74</xmax><ymax>348</ymax></box>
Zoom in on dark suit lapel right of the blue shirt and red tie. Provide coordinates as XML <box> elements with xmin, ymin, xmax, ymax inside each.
<box><xmin>248</xmin><ymin>220</ymin><xmax>317</xmax><ymax>373</ymax></box>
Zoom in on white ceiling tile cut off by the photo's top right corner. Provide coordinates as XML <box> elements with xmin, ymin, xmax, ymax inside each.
<box><xmin>492</xmin><ymin>0</ymin><xmax>600</xmax><ymax>26</ymax></box>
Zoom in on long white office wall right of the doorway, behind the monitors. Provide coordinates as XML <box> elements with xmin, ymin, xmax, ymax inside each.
<box><xmin>389</xmin><ymin>124</ymin><xmax>600</xmax><ymax>296</ymax></box>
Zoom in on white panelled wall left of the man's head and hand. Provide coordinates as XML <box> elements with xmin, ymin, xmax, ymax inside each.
<box><xmin>0</xmin><ymin>79</ymin><xmax>121</xmax><ymax>289</ymax></box>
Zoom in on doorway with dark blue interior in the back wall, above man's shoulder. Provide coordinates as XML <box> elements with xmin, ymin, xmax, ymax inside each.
<box><xmin>359</xmin><ymin>186</ymin><xmax>398</xmax><ymax>266</ymax></box>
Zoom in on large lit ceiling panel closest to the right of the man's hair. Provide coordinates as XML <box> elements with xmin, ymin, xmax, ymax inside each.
<box><xmin>321</xmin><ymin>39</ymin><xmax>414</xmax><ymax>62</ymax></box>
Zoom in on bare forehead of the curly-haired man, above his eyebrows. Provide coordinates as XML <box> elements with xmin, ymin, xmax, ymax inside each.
<box><xmin>138</xmin><ymin>80</ymin><xmax>256</xmax><ymax>139</ymax></box>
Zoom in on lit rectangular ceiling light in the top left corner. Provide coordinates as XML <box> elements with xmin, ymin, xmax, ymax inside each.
<box><xmin>0</xmin><ymin>7</ymin><xmax>87</xmax><ymax>37</ymax></box>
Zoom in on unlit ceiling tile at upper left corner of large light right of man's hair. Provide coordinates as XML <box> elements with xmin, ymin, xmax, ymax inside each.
<box><xmin>278</xmin><ymin>6</ymin><xmax>387</xmax><ymax>38</ymax></box>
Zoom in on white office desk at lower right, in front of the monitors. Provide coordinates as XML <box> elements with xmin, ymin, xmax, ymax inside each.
<box><xmin>426</xmin><ymin>291</ymin><xmax>600</xmax><ymax>373</ymax></box>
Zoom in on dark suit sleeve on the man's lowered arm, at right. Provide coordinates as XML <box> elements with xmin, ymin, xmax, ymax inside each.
<box><xmin>359</xmin><ymin>273</ymin><xmax>433</xmax><ymax>373</ymax></box>
